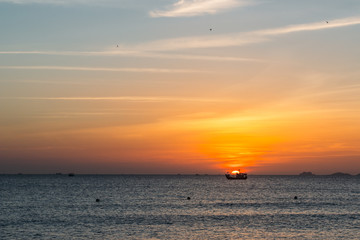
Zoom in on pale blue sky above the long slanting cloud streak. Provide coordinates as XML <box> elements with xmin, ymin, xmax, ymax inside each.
<box><xmin>1</xmin><ymin>0</ymin><xmax>359</xmax><ymax>51</ymax></box>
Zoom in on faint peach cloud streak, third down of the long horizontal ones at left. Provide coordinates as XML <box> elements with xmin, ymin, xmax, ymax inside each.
<box><xmin>0</xmin><ymin>96</ymin><xmax>230</xmax><ymax>102</ymax></box>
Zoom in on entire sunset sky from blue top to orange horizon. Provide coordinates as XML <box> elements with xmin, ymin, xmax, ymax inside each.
<box><xmin>0</xmin><ymin>0</ymin><xmax>360</xmax><ymax>174</ymax></box>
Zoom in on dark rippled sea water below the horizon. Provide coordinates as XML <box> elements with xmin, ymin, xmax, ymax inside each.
<box><xmin>0</xmin><ymin>175</ymin><xmax>360</xmax><ymax>239</ymax></box>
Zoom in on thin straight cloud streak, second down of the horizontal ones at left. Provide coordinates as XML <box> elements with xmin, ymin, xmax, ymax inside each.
<box><xmin>0</xmin><ymin>66</ymin><xmax>203</xmax><ymax>73</ymax></box>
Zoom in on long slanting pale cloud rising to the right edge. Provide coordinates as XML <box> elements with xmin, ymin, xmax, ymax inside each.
<box><xmin>124</xmin><ymin>17</ymin><xmax>360</xmax><ymax>51</ymax></box>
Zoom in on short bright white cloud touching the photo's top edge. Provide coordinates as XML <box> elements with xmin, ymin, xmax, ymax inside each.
<box><xmin>150</xmin><ymin>0</ymin><xmax>248</xmax><ymax>17</ymax></box>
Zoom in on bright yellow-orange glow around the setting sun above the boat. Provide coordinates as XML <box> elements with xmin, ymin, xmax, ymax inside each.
<box><xmin>193</xmin><ymin>116</ymin><xmax>281</xmax><ymax>172</ymax></box>
